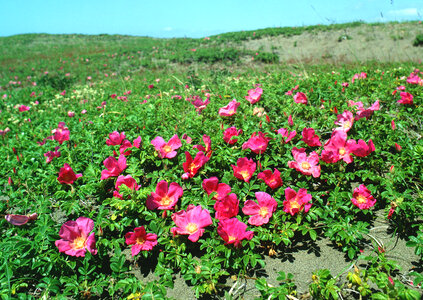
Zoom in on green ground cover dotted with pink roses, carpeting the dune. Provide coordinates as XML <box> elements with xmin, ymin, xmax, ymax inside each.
<box><xmin>0</xmin><ymin>21</ymin><xmax>423</xmax><ymax>299</ymax></box>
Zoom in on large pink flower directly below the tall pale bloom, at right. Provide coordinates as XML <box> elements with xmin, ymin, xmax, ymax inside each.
<box><xmin>321</xmin><ymin>130</ymin><xmax>356</xmax><ymax>164</ymax></box>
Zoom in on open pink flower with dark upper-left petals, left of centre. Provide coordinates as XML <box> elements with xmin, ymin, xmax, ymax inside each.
<box><xmin>146</xmin><ymin>180</ymin><xmax>184</xmax><ymax>210</ymax></box>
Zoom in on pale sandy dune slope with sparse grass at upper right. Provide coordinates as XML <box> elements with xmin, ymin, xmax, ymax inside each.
<box><xmin>240</xmin><ymin>22</ymin><xmax>423</xmax><ymax>64</ymax></box>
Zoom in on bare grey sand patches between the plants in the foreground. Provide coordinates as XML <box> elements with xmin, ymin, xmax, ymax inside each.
<box><xmin>128</xmin><ymin>211</ymin><xmax>422</xmax><ymax>300</ymax></box>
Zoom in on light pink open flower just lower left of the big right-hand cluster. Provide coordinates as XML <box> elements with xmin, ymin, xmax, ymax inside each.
<box><xmin>288</xmin><ymin>147</ymin><xmax>320</xmax><ymax>178</ymax></box>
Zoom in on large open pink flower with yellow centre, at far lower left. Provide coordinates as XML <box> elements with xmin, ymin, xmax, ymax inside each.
<box><xmin>55</xmin><ymin>217</ymin><xmax>97</xmax><ymax>257</ymax></box>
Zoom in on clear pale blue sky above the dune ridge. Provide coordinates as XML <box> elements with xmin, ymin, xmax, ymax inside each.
<box><xmin>0</xmin><ymin>0</ymin><xmax>423</xmax><ymax>37</ymax></box>
